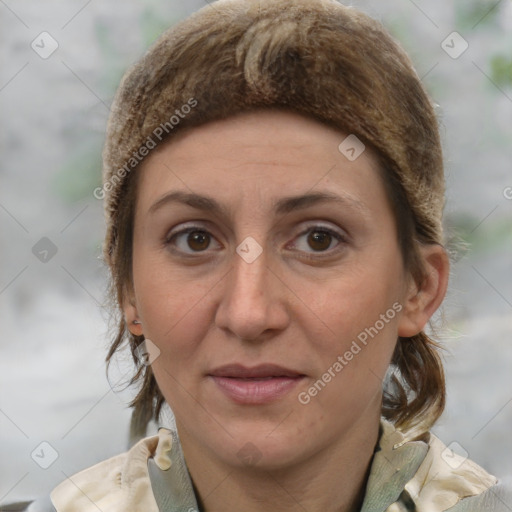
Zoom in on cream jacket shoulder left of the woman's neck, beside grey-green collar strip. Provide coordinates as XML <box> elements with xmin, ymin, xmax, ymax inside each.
<box><xmin>46</xmin><ymin>429</ymin><xmax>172</xmax><ymax>512</ymax></box>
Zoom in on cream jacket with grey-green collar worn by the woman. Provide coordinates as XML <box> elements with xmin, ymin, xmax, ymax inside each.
<box><xmin>19</xmin><ymin>420</ymin><xmax>512</xmax><ymax>512</ymax></box>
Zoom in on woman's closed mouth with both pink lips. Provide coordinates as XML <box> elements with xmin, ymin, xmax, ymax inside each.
<box><xmin>208</xmin><ymin>364</ymin><xmax>306</xmax><ymax>405</ymax></box>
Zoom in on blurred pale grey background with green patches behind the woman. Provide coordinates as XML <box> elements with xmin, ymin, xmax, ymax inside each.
<box><xmin>0</xmin><ymin>0</ymin><xmax>512</xmax><ymax>503</ymax></box>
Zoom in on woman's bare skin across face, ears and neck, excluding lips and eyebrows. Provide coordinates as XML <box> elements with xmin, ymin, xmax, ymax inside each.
<box><xmin>124</xmin><ymin>111</ymin><xmax>448</xmax><ymax>512</ymax></box>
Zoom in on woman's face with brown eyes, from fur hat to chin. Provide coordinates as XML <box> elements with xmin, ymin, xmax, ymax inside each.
<box><xmin>125</xmin><ymin>111</ymin><xmax>416</xmax><ymax>467</ymax></box>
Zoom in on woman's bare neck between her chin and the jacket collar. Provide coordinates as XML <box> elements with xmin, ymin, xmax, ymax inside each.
<box><xmin>178</xmin><ymin>402</ymin><xmax>380</xmax><ymax>512</ymax></box>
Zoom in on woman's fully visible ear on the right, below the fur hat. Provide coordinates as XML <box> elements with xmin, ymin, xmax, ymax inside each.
<box><xmin>398</xmin><ymin>244</ymin><xmax>450</xmax><ymax>338</ymax></box>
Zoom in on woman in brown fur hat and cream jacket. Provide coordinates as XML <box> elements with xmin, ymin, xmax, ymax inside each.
<box><xmin>22</xmin><ymin>0</ymin><xmax>512</xmax><ymax>512</ymax></box>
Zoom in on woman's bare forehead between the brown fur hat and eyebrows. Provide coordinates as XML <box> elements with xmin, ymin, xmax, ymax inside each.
<box><xmin>137</xmin><ymin>110</ymin><xmax>384</xmax><ymax>216</ymax></box>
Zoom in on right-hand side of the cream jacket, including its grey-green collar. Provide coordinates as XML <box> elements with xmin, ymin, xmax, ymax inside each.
<box><xmin>362</xmin><ymin>420</ymin><xmax>512</xmax><ymax>512</ymax></box>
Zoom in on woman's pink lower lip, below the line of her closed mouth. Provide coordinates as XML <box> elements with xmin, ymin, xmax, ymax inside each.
<box><xmin>212</xmin><ymin>376</ymin><xmax>304</xmax><ymax>405</ymax></box>
